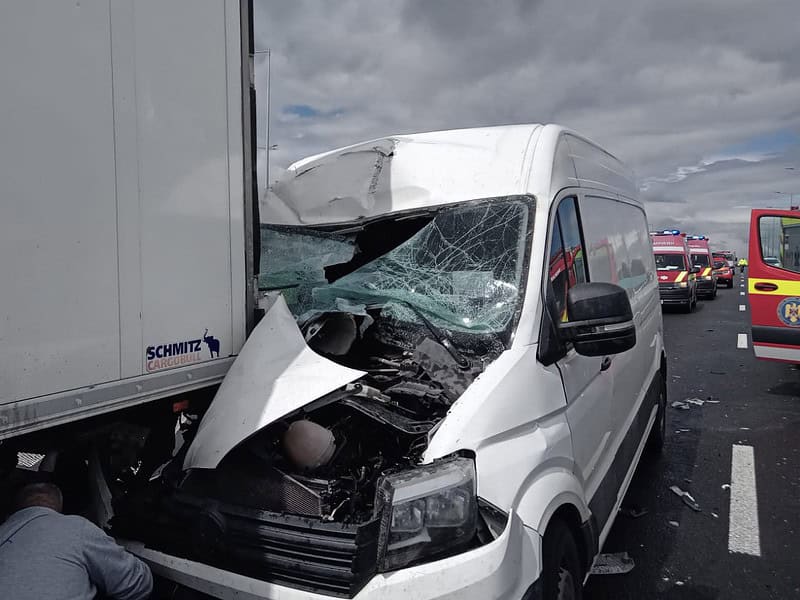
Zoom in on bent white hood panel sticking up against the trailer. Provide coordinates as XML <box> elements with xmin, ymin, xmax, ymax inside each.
<box><xmin>183</xmin><ymin>296</ymin><xmax>365</xmax><ymax>469</ymax></box>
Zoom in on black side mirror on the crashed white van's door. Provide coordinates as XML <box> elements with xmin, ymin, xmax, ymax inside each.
<box><xmin>558</xmin><ymin>282</ymin><xmax>636</xmax><ymax>356</ymax></box>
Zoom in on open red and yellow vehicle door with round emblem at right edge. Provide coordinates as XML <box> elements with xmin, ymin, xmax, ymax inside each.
<box><xmin>748</xmin><ymin>210</ymin><xmax>800</xmax><ymax>363</ymax></box>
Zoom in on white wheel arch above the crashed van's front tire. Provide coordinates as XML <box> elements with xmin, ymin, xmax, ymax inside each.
<box><xmin>516</xmin><ymin>468</ymin><xmax>592</xmax><ymax>535</ymax></box>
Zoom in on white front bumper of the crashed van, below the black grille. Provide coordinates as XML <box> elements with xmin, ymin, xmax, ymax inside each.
<box><xmin>118</xmin><ymin>512</ymin><xmax>542</xmax><ymax>600</ymax></box>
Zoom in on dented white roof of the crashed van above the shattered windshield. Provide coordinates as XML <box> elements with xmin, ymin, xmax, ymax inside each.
<box><xmin>262</xmin><ymin>124</ymin><xmax>636</xmax><ymax>225</ymax></box>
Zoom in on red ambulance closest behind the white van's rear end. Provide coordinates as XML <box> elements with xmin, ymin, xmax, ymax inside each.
<box><xmin>650</xmin><ymin>229</ymin><xmax>700</xmax><ymax>313</ymax></box>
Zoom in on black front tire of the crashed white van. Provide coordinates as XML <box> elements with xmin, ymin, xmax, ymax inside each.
<box><xmin>542</xmin><ymin>518</ymin><xmax>583</xmax><ymax>600</ymax></box>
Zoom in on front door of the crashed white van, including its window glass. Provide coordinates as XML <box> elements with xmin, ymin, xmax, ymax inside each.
<box><xmin>540</xmin><ymin>196</ymin><xmax>613</xmax><ymax>520</ymax></box>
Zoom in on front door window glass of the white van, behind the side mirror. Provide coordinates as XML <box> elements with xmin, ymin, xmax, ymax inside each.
<box><xmin>548</xmin><ymin>198</ymin><xmax>587</xmax><ymax>321</ymax></box>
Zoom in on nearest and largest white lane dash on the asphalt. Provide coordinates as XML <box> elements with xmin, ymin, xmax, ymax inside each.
<box><xmin>728</xmin><ymin>444</ymin><xmax>761</xmax><ymax>556</ymax></box>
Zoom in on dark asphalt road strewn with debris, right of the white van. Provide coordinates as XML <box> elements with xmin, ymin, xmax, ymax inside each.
<box><xmin>585</xmin><ymin>274</ymin><xmax>800</xmax><ymax>600</ymax></box>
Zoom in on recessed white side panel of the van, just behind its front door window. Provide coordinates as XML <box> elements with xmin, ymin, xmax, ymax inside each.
<box><xmin>580</xmin><ymin>196</ymin><xmax>655</xmax><ymax>298</ymax></box>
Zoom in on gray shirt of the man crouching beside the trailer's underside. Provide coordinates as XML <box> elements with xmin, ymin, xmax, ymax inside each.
<box><xmin>0</xmin><ymin>506</ymin><xmax>153</xmax><ymax>600</ymax></box>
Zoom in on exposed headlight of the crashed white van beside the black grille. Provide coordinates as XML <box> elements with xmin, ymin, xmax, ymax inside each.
<box><xmin>376</xmin><ymin>458</ymin><xmax>478</xmax><ymax>571</ymax></box>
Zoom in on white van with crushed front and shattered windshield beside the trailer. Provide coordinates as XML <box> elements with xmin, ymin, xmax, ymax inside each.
<box><xmin>112</xmin><ymin>125</ymin><xmax>666</xmax><ymax>600</ymax></box>
